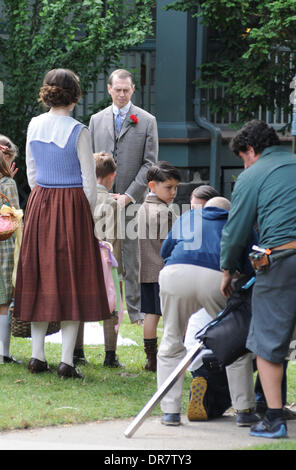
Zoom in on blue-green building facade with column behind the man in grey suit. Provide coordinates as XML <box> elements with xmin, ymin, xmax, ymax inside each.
<box><xmin>0</xmin><ymin>0</ymin><xmax>291</xmax><ymax>203</ymax></box>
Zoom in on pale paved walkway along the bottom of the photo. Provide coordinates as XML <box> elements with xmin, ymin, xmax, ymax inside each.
<box><xmin>0</xmin><ymin>416</ymin><xmax>296</xmax><ymax>455</ymax></box>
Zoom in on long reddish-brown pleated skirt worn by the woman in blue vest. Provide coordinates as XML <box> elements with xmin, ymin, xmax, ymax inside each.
<box><xmin>14</xmin><ymin>186</ymin><xmax>110</xmax><ymax>322</ymax></box>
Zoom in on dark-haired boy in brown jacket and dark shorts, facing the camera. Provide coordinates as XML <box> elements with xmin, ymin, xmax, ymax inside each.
<box><xmin>138</xmin><ymin>162</ymin><xmax>181</xmax><ymax>372</ymax></box>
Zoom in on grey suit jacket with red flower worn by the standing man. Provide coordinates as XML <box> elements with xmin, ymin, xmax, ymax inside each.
<box><xmin>89</xmin><ymin>104</ymin><xmax>158</xmax><ymax>203</ymax></box>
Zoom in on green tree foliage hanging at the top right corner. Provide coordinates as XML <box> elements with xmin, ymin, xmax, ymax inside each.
<box><xmin>167</xmin><ymin>0</ymin><xmax>296</xmax><ymax>124</ymax></box>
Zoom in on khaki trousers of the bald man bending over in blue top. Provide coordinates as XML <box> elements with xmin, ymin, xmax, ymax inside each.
<box><xmin>157</xmin><ymin>264</ymin><xmax>254</xmax><ymax>413</ymax></box>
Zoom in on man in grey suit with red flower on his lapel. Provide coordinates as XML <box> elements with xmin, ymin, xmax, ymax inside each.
<box><xmin>89</xmin><ymin>69</ymin><xmax>158</xmax><ymax>323</ymax></box>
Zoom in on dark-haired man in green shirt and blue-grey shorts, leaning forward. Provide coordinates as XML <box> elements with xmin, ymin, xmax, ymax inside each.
<box><xmin>220</xmin><ymin>120</ymin><xmax>296</xmax><ymax>438</ymax></box>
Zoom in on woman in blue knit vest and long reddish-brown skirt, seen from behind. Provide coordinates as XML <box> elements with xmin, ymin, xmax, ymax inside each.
<box><xmin>15</xmin><ymin>69</ymin><xmax>110</xmax><ymax>378</ymax></box>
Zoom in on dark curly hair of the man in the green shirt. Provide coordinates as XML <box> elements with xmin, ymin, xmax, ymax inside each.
<box><xmin>229</xmin><ymin>119</ymin><xmax>281</xmax><ymax>155</ymax></box>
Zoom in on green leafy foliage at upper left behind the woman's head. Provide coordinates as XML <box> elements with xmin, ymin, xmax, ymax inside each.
<box><xmin>0</xmin><ymin>0</ymin><xmax>155</xmax><ymax>161</ymax></box>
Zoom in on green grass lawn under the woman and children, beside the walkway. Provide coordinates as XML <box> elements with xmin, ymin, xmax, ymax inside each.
<box><xmin>0</xmin><ymin>315</ymin><xmax>191</xmax><ymax>431</ymax></box>
